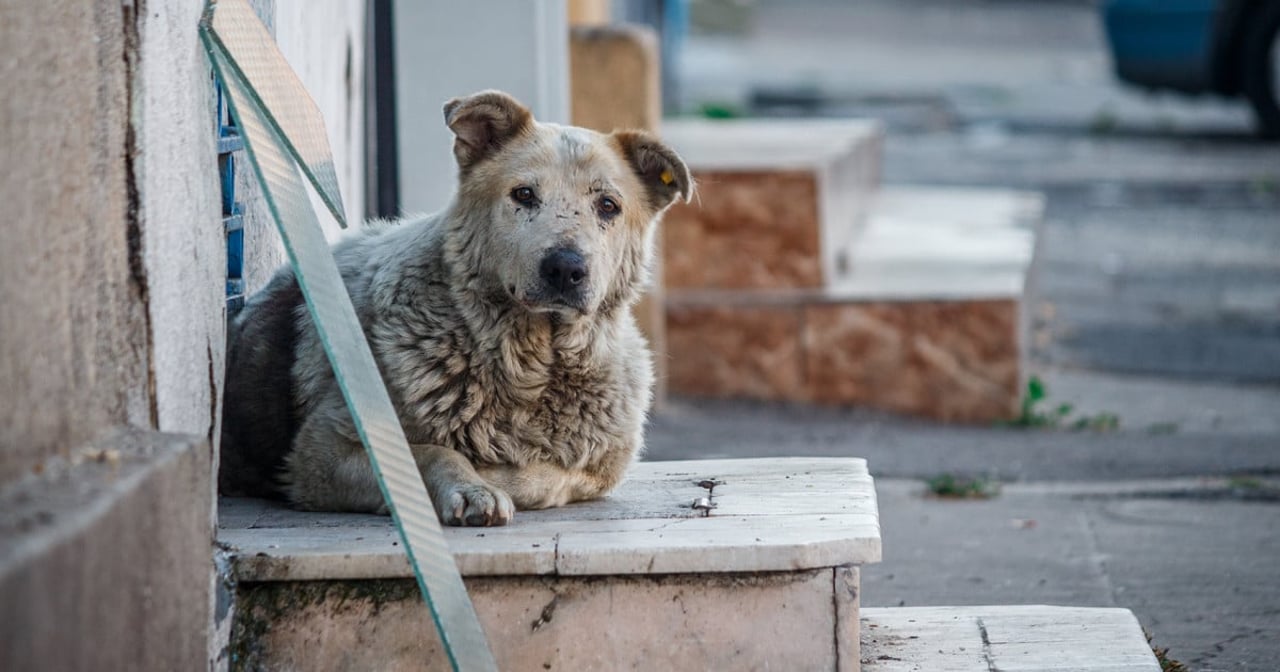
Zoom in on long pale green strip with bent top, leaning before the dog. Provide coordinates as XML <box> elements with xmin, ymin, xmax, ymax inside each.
<box><xmin>201</xmin><ymin>0</ymin><xmax>497</xmax><ymax>671</ymax></box>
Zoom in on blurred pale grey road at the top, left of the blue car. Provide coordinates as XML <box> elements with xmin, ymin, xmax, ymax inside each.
<box><xmin>677</xmin><ymin>0</ymin><xmax>1249</xmax><ymax>134</ymax></box>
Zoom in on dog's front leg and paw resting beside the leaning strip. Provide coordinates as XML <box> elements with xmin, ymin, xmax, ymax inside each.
<box><xmin>412</xmin><ymin>444</ymin><xmax>516</xmax><ymax>526</ymax></box>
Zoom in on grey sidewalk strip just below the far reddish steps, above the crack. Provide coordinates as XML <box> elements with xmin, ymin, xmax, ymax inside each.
<box><xmin>645</xmin><ymin>370</ymin><xmax>1280</xmax><ymax>481</ymax></box>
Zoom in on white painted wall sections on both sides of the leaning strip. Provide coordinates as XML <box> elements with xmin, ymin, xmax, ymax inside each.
<box><xmin>133</xmin><ymin>0</ymin><xmax>365</xmax><ymax>438</ymax></box>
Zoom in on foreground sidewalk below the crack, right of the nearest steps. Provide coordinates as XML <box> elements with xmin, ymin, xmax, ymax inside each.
<box><xmin>863</xmin><ymin>479</ymin><xmax>1280</xmax><ymax>672</ymax></box>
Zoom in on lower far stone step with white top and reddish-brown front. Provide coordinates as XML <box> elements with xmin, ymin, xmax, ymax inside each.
<box><xmin>666</xmin><ymin>187</ymin><xmax>1043</xmax><ymax>422</ymax></box>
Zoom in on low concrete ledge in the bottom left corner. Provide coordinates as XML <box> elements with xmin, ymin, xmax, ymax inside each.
<box><xmin>0</xmin><ymin>430</ymin><xmax>212</xmax><ymax>672</ymax></box>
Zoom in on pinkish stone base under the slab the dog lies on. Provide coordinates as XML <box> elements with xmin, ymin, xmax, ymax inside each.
<box><xmin>232</xmin><ymin>567</ymin><xmax>859</xmax><ymax>672</ymax></box>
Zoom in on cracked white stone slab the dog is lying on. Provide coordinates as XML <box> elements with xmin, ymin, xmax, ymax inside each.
<box><xmin>218</xmin><ymin>458</ymin><xmax>881</xmax><ymax>581</ymax></box>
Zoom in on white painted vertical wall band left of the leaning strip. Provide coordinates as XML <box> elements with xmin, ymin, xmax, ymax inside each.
<box><xmin>140</xmin><ymin>3</ymin><xmax>227</xmax><ymax>436</ymax></box>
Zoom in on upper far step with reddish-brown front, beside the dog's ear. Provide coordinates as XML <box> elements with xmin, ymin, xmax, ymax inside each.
<box><xmin>662</xmin><ymin>119</ymin><xmax>883</xmax><ymax>289</ymax></box>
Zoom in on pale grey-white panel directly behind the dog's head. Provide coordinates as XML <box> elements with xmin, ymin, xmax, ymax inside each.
<box><xmin>393</xmin><ymin>0</ymin><xmax>570</xmax><ymax>212</ymax></box>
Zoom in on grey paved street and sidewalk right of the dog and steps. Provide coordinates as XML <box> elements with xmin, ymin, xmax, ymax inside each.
<box><xmin>649</xmin><ymin>0</ymin><xmax>1280</xmax><ymax>671</ymax></box>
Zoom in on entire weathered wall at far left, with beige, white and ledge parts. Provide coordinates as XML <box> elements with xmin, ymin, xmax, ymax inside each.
<box><xmin>0</xmin><ymin>0</ymin><xmax>365</xmax><ymax>669</ymax></box>
